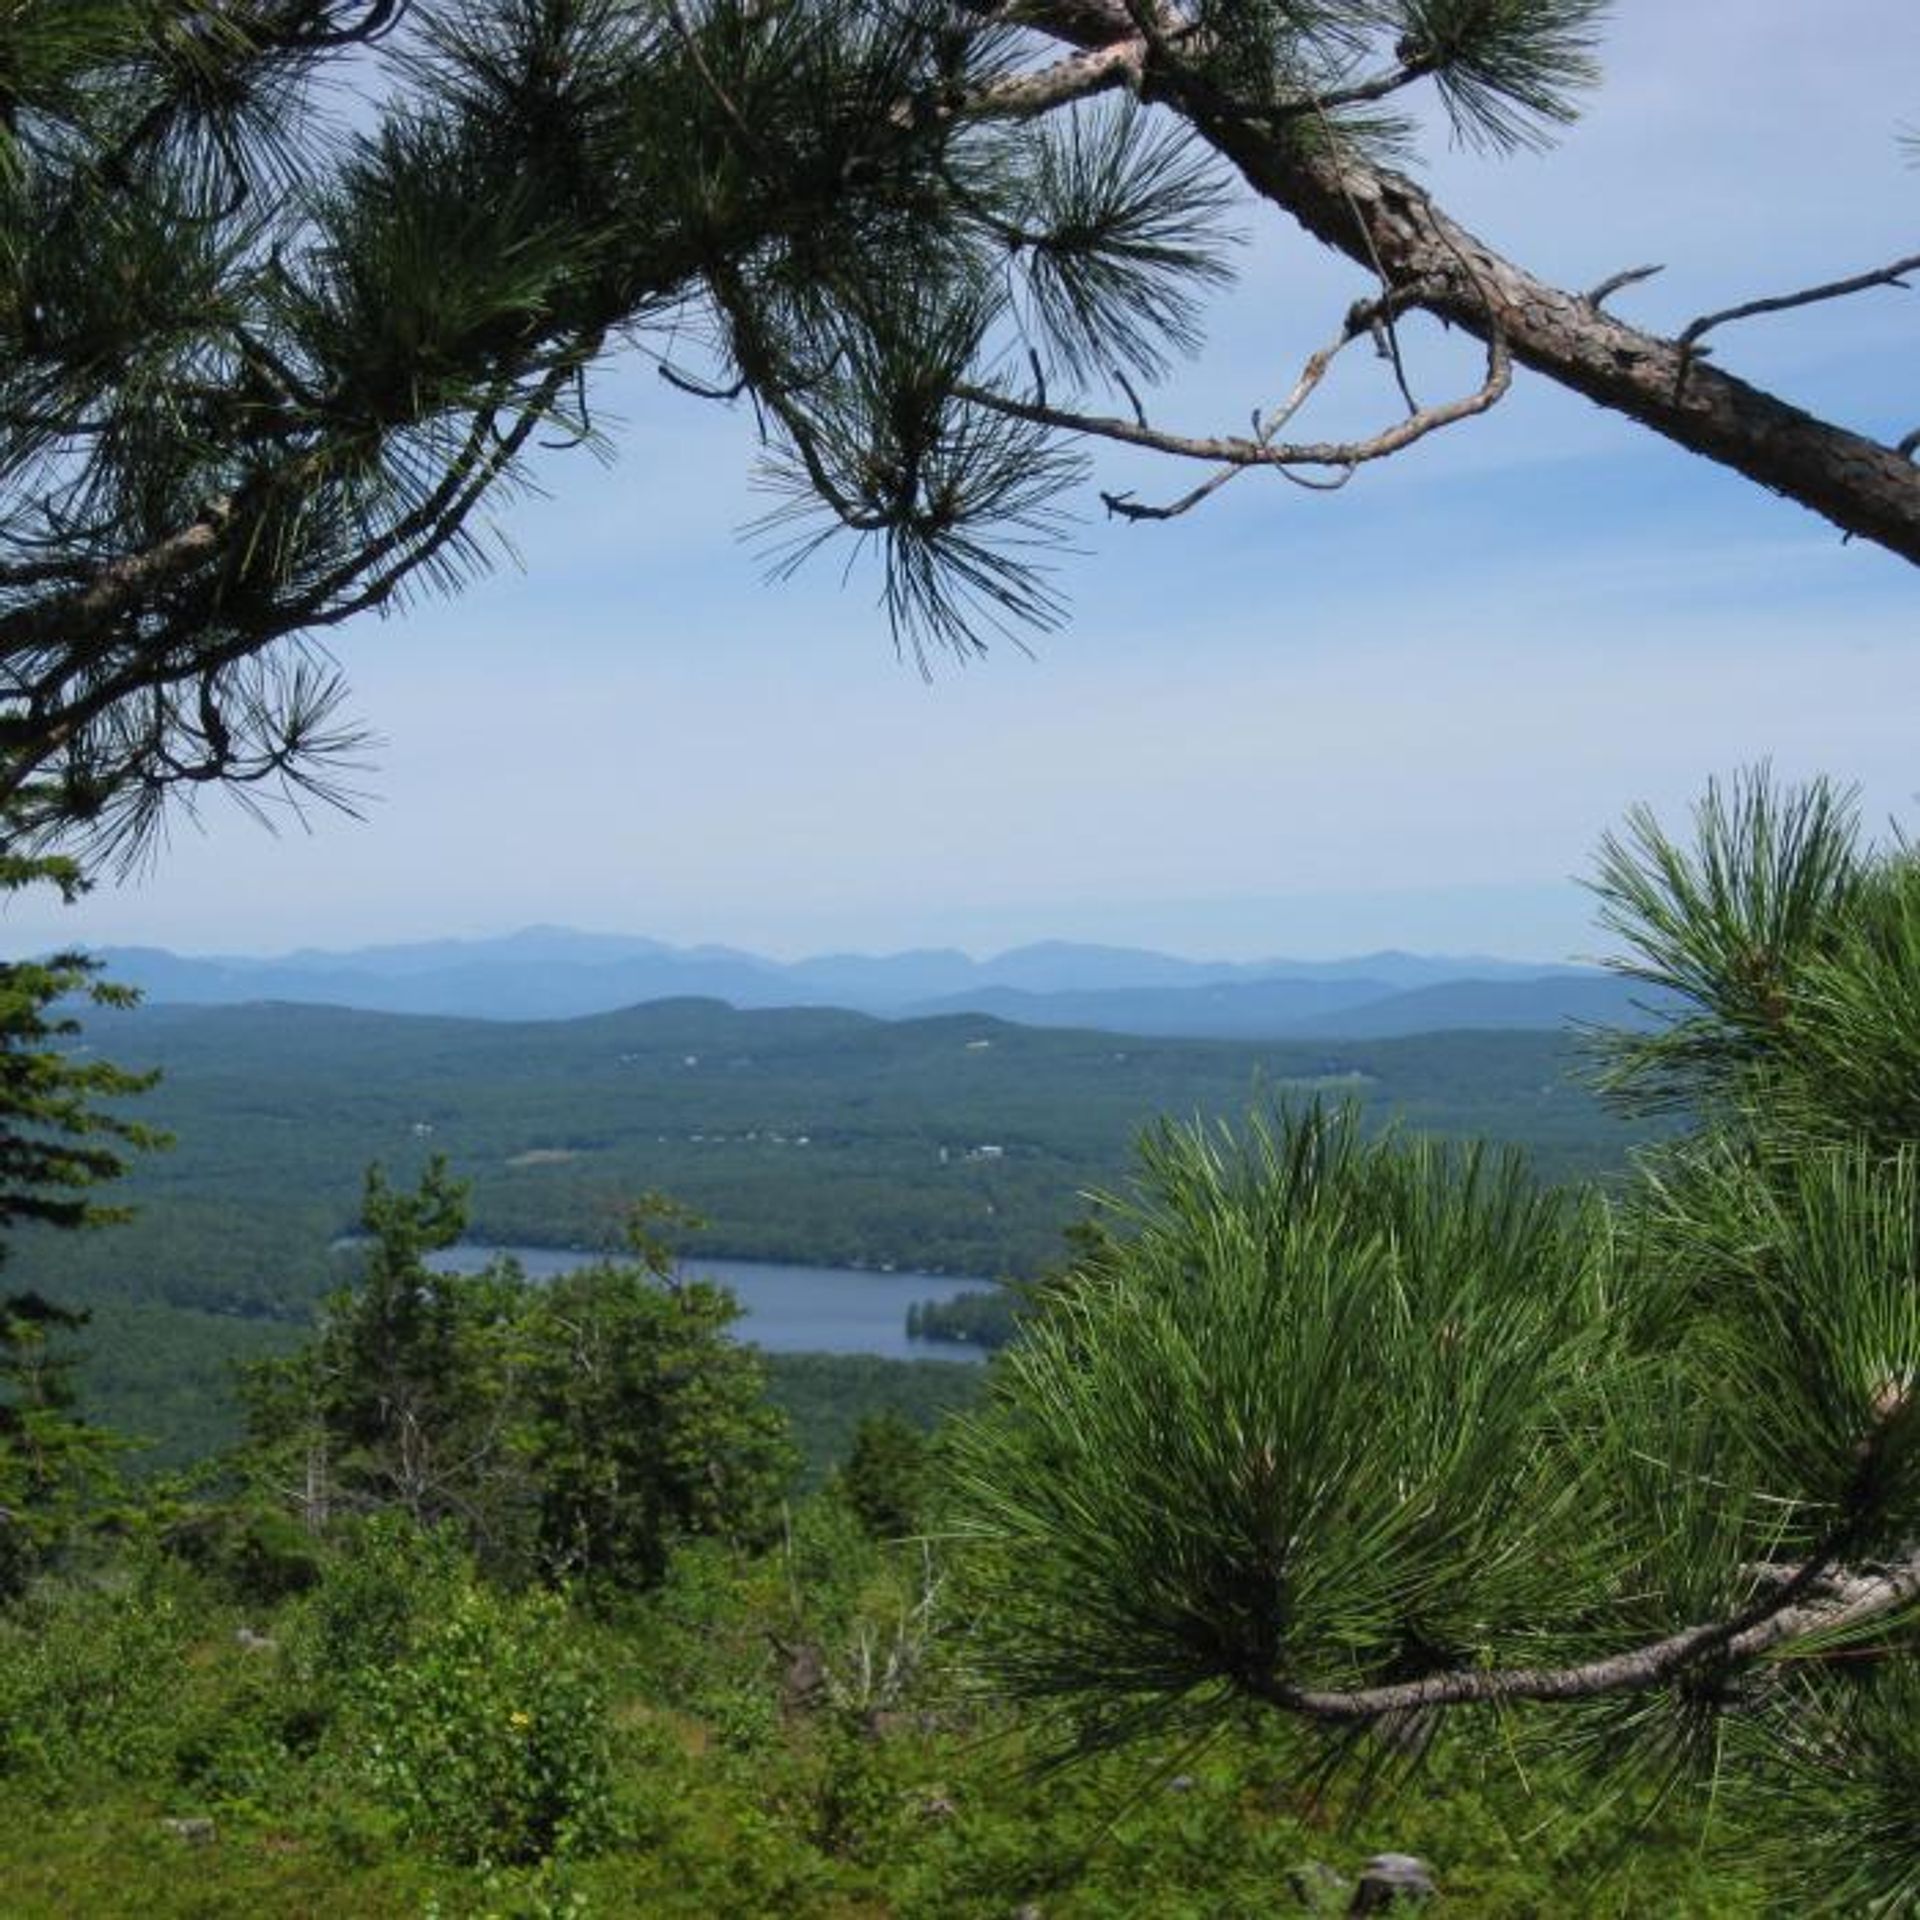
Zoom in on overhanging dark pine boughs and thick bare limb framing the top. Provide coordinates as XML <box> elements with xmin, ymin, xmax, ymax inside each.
<box><xmin>0</xmin><ymin>0</ymin><xmax>1920</xmax><ymax>851</ymax></box>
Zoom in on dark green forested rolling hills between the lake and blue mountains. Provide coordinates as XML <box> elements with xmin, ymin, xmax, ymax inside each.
<box><xmin>10</xmin><ymin>1000</ymin><xmax>1658</xmax><ymax>1459</ymax></box>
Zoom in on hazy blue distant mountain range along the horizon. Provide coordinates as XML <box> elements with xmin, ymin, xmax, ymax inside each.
<box><xmin>71</xmin><ymin>927</ymin><xmax>1649</xmax><ymax>1039</ymax></box>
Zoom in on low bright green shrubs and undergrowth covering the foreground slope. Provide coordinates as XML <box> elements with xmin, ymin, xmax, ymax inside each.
<box><xmin>0</xmin><ymin>1500</ymin><xmax>1772</xmax><ymax>1920</ymax></box>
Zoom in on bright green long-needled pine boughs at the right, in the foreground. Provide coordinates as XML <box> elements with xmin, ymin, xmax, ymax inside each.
<box><xmin>960</xmin><ymin>772</ymin><xmax>1920</xmax><ymax>1912</ymax></box>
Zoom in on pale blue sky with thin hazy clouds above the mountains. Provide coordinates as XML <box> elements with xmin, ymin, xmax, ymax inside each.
<box><xmin>0</xmin><ymin>0</ymin><xmax>1920</xmax><ymax>958</ymax></box>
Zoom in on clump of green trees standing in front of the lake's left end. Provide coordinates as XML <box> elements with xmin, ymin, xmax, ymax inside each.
<box><xmin>246</xmin><ymin>1160</ymin><xmax>795</xmax><ymax>1588</ymax></box>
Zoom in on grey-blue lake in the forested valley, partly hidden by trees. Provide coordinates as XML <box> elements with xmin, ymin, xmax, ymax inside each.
<box><xmin>428</xmin><ymin>1240</ymin><xmax>993</xmax><ymax>1361</ymax></box>
